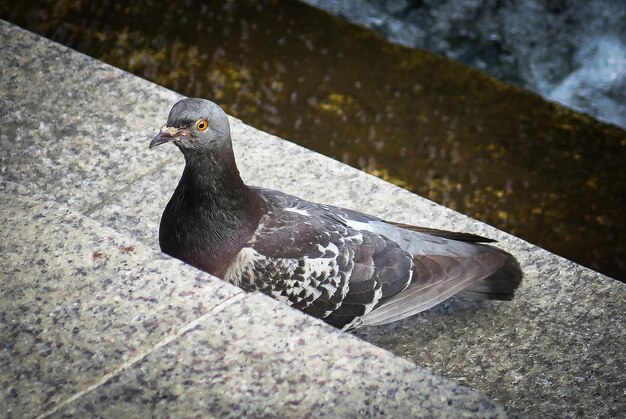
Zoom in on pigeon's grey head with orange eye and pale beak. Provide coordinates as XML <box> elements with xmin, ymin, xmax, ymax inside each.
<box><xmin>150</xmin><ymin>98</ymin><xmax>230</xmax><ymax>154</ymax></box>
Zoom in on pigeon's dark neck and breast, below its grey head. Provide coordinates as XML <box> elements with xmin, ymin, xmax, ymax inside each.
<box><xmin>159</xmin><ymin>150</ymin><xmax>265</xmax><ymax>277</ymax></box>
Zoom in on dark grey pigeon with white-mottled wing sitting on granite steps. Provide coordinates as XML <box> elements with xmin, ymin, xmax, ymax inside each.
<box><xmin>149</xmin><ymin>98</ymin><xmax>523</xmax><ymax>330</ymax></box>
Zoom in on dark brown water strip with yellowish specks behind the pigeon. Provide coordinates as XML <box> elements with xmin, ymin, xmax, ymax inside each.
<box><xmin>0</xmin><ymin>0</ymin><xmax>626</xmax><ymax>280</ymax></box>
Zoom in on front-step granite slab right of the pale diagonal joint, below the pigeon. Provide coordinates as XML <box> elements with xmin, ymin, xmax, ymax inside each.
<box><xmin>54</xmin><ymin>294</ymin><xmax>507</xmax><ymax>417</ymax></box>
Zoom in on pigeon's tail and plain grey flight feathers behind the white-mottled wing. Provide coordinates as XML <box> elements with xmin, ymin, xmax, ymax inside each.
<box><xmin>322</xmin><ymin>208</ymin><xmax>522</xmax><ymax>327</ymax></box>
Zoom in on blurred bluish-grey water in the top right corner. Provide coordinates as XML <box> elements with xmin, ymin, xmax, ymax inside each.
<box><xmin>303</xmin><ymin>0</ymin><xmax>626</xmax><ymax>127</ymax></box>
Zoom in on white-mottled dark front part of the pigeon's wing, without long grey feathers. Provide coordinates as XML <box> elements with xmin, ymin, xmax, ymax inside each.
<box><xmin>225</xmin><ymin>189</ymin><xmax>413</xmax><ymax>328</ymax></box>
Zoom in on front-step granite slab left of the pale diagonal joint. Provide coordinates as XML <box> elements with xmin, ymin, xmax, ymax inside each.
<box><xmin>0</xmin><ymin>182</ymin><xmax>242</xmax><ymax>417</ymax></box>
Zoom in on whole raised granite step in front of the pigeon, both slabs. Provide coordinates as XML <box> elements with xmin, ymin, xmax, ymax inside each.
<box><xmin>0</xmin><ymin>182</ymin><xmax>512</xmax><ymax>417</ymax></box>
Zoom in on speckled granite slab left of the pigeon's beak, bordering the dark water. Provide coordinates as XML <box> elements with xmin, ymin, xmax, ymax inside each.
<box><xmin>0</xmin><ymin>22</ymin><xmax>177</xmax><ymax>212</ymax></box>
